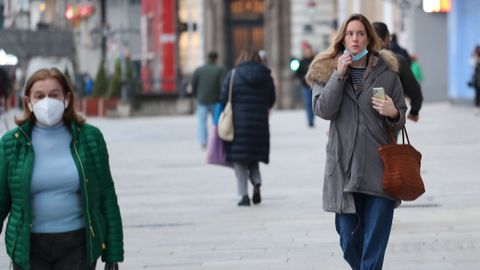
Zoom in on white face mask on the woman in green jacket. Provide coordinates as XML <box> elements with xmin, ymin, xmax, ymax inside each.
<box><xmin>28</xmin><ymin>97</ymin><xmax>68</xmax><ymax>126</ymax></box>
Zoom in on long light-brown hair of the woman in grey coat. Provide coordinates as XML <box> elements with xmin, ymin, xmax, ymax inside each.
<box><xmin>307</xmin><ymin>14</ymin><xmax>382</xmax><ymax>69</ymax></box>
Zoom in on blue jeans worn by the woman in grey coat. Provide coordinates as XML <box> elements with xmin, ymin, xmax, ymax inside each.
<box><xmin>335</xmin><ymin>193</ymin><xmax>395</xmax><ymax>270</ymax></box>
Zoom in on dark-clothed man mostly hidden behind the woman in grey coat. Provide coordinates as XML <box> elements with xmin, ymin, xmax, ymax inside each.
<box><xmin>373</xmin><ymin>22</ymin><xmax>423</xmax><ymax>122</ymax></box>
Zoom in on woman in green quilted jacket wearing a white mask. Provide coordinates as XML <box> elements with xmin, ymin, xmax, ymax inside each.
<box><xmin>0</xmin><ymin>68</ymin><xmax>124</xmax><ymax>270</ymax></box>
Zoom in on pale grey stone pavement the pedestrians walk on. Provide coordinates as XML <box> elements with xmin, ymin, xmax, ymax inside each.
<box><xmin>0</xmin><ymin>103</ymin><xmax>480</xmax><ymax>270</ymax></box>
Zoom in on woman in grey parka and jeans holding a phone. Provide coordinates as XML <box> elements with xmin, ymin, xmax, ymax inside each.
<box><xmin>307</xmin><ymin>14</ymin><xmax>407</xmax><ymax>270</ymax></box>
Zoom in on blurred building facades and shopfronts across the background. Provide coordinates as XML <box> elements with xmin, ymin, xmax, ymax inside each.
<box><xmin>0</xmin><ymin>0</ymin><xmax>480</xmax><ymax>114</ymax></box>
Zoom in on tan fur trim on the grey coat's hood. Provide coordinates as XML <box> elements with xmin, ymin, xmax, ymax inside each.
<box><xmin>305</xmin><ymin>50</ymin><xmax>399</xmax><ymax>86</ymax></box>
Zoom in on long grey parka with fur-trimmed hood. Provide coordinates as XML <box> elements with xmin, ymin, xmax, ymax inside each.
<box><xmin>307</xmin><ymin>51</ymin><xmax>407</xmax><ymax>213</ymax></box>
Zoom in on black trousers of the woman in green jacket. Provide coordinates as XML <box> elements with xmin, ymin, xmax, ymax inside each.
<box><xmin>13</xmin><ymin>229</ymin><xmax>96</xmax><ymax>270</ymax></box>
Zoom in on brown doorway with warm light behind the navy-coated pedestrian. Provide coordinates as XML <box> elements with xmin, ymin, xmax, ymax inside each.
<box><xmin>225</xmin><ymin>0</ymin><xmax>265</xmax><ymax>67</ymax></box>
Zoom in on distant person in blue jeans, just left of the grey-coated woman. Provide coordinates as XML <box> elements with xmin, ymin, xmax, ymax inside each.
<box><xmin>295</xmin><ymin>42</ymin><xmax>315</xmax><ymax>127</ymax></box>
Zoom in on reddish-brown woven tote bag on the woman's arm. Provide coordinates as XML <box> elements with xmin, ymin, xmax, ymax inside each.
<box><xmin>379</xmin><ymin>126</ymin><xmax>425</xmax><ymax>201</ymax></box>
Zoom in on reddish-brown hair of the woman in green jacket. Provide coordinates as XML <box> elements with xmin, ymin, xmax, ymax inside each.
<box><xmin>15</xmin><ymin>68</ymin><xmax>85</xmax><ymax>125</ymax></box>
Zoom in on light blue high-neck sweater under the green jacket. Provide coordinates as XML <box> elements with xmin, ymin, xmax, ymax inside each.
<box><xmin>30</xmin><ymin>124</ymin><xmax>85</xmax><ymax>233</ymax></box>
